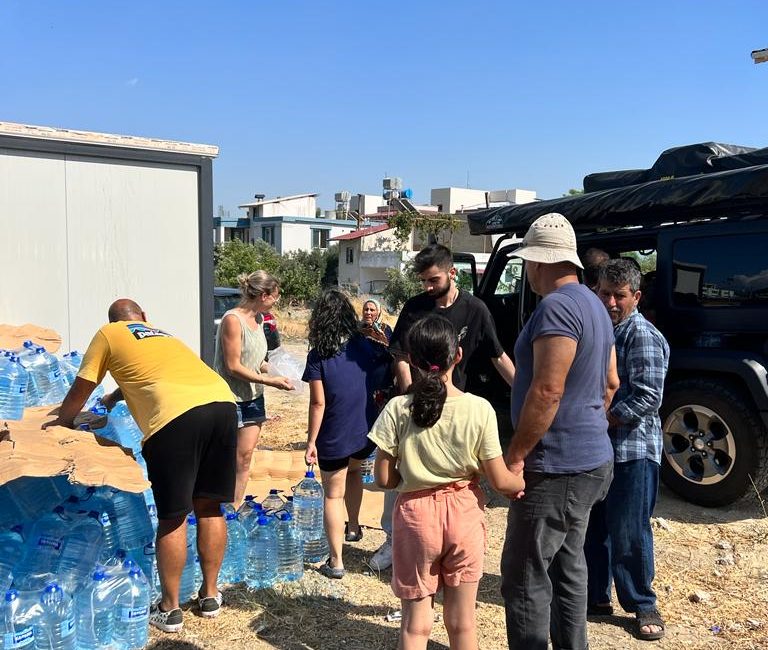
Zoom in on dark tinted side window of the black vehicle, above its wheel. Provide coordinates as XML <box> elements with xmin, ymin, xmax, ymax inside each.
<box><xmin>672</xmin><ymin>234</ymin><xmax>768</xmax><ymax>307</ymax></box>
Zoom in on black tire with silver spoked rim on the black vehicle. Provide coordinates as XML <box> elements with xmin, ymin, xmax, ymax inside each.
<box><xmin>660</xmin><ymin>379</ymin><xmax>768</xmax><ymax>506</ymax></box>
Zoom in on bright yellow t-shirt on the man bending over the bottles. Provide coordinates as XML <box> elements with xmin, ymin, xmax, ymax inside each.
<box><xmin>77</xmin><ymin>321</ymin><xmax>234</xmax><ymax>442</ymax></box>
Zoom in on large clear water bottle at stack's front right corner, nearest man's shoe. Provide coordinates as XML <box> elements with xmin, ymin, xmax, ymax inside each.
<box><xmin>113</xmin><ymin>564</ymin><xmax>150</xmax><ymax>650</ymax></box>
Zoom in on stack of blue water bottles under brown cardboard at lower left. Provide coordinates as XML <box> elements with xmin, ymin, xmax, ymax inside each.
<box><xmin>0</xmin><ymin>484</ymin><xmax>157</xmax><ymax>650</ymax></box>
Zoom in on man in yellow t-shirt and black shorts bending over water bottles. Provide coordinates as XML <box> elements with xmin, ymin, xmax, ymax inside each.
<box><xmin>49</xmin><ymin>298</ymin><xmax>237</xmax><ymax>632</ymax></box>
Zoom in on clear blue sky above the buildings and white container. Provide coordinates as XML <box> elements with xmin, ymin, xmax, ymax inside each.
<box><xmin>0</xmin><ymin>0</ymin><xmax>768</xmax><ymax>215</ymax></box>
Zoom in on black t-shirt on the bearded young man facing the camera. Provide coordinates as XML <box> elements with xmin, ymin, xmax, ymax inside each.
<box><xmin>389</xmin><ymin>289</ymin><xmax>504</xmax><ymax>390</ymax></box>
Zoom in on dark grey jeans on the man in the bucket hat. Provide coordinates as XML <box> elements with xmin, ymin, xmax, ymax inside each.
<box><xmin>501</xmin><ymin>462</ymin><xmax>613</xmax><ymax>650</ymax></box>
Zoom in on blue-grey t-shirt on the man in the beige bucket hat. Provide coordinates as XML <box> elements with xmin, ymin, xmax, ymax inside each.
<box><xmin>512</xmin><ymin>282</ymin><xmax>613</xmax><ymax>474</ymax></box>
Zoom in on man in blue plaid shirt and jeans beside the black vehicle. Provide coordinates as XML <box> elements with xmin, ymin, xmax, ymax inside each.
<box><xmin>584</xmin><ymin>258</ymin><xmax>669</xmax><ymax>641</ymax></box>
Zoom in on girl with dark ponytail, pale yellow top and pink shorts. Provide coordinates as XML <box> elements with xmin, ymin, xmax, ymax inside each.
<box><xmin>368</xmin><ymin>314</ymin><xmax>524</xmax><ymax>650</ymax></box>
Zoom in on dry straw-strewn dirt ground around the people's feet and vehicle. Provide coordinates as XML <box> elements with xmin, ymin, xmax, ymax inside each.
<box><xmin>150</xmin><ymin>339</ymin><xmax>768</xmax><ymax>650</ymax></box>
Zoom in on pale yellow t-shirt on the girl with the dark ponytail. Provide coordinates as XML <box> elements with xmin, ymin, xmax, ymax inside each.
<box><xmin>368</xmin><ymin>393</ymin><xmax>501</xmax><ymax>492</ymax></box>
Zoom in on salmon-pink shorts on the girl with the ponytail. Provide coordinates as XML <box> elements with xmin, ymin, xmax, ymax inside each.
<box><xmin>392</xmin><ymin>481</ymin><xmax>487</xmax><ymax>600</ymax></box>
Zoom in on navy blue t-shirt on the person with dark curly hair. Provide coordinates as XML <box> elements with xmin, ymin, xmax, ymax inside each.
<box><xmin>301</xmin><ymin>336</ymin><xmax>376</xmax><ymax>460</ymax></box>
